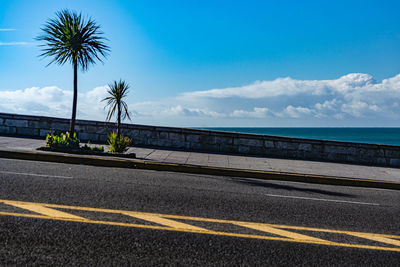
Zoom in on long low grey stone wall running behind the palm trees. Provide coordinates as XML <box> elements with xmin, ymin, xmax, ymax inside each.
<box><xmin>0</xmin><ymin>113</ymin><xmax>400</xmax><ymax>167</ymax></box>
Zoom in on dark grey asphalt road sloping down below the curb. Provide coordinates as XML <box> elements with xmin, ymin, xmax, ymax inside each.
<box><xmin>0</xmin><ymin>159</ymin><xmax>400</xmax><ymax>266</ymax></box>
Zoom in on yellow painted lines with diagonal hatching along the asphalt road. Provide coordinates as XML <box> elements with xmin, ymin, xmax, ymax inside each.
<box><xmin>0</xmin><ymin>200</ymin><xmax>400</xmax><ymax>252</ymax></box>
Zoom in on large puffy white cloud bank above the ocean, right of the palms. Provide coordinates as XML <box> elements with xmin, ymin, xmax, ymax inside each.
<box><xmin>178</xmin><ymin>73</ymin><xmax>400</xmax><ymax>124</ymax></box>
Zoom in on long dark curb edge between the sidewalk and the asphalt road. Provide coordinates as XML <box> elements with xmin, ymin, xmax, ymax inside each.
<box><xmin>0</xmin><ymin>150</ymin><xmax>400</xmax><ymax>190</ymax></box>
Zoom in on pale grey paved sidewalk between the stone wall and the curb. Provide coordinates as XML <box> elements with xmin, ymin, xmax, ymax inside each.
<box><xmin>0</xmin><ymin>136</ymin><xmax>400</xmax><ymax>186</ymax></box>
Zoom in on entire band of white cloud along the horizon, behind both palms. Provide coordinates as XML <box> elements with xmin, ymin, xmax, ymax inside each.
<box><xmin>0</xmin><ymin>73</ymin><xmax>400</xmax><ymax>126</ymax></box>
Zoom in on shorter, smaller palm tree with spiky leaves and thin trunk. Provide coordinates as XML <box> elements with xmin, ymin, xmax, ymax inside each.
<box><xmin>102</xmin><ymin>80</ymin><xmax>131</xmax><ymax>138</ymax></box>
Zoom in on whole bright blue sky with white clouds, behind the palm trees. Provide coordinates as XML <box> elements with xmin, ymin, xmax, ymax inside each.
<box><xmin>0</xmin><ymin>0</ymin><xmax>400</xmax><ymax>127</ymax></box>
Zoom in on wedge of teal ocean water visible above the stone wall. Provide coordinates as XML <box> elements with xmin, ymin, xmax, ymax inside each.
<box><xmin>198</xmin><ymin>127</ymin><xmax>400</xmax><ymax>145</ymax></box>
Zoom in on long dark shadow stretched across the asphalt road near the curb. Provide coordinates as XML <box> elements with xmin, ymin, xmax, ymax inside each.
<box><xmin>232</xmin><ymin>178</ymin><xmax>356</xmax><ymax>198</ymax></box>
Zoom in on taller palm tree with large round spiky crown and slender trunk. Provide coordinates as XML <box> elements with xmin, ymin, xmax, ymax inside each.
<box><xmin>36</xmin><ymin>9</ymin><xmax>110</xmax><ymax>134</ymax></box>
